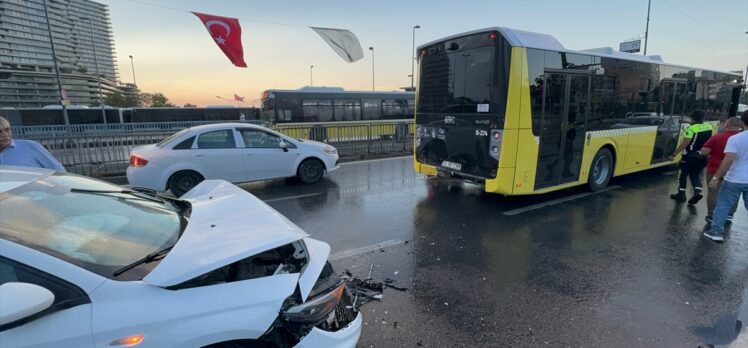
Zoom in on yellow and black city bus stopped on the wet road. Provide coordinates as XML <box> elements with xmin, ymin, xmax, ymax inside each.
<box><xmin>414</xmin><ymin>28</ymin><xmax>742</xmax><ymax>195</ymax></box>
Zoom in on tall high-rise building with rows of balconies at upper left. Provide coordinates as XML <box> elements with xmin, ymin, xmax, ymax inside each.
<box><xmin>0</xmin><ymin>0</ymin><xmax>118</xmax><ymax>108</ymax></box>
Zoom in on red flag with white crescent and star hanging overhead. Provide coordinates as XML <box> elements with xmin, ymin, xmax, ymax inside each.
<box><xmin>192</xmin><ymin>12</ymin><xmax>247</xmax><ymax>68</ymax></box>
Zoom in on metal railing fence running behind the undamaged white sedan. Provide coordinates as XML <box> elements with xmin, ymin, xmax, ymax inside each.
<box><xmin>12</xmin><ymin>120</ymin><xmax>414</xmax><ymax>176</ymax></box>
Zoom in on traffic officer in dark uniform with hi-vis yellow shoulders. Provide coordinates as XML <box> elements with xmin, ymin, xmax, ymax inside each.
<box><xmin>670</xmin><ymin>109</ymin><xmax>712</xmax><ymax>204</ymax></box>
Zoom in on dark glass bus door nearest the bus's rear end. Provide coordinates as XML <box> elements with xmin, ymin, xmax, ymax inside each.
<box><xmin>535</xmin><ymin>72</ymin><xmax>590</xmax><ymax>190</ymax></box>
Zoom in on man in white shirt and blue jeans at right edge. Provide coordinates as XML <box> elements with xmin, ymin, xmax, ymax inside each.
<box><xmin>704</xmin><ymin>111</ymin><xmax>748</xmax><ymax>242</ymax></box>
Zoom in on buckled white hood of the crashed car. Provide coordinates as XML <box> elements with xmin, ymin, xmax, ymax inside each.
<box><xmin>143</xmin><ymin>180</ymin><xmax>308</xmax><ymax>287</ymax></box>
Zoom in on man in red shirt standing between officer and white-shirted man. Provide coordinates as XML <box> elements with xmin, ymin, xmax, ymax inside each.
<box><xmin>701</xmin><ymin>117</ymin><xmax>743</xmax><ymax>222</ymax></box>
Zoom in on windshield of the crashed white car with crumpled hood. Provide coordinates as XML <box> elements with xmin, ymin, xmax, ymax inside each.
<box><xmin>0</xmin><ymin>173</ymin><xmax>186</xmax><ymax>280</ymax></box>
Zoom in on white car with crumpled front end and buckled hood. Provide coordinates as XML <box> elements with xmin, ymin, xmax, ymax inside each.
<box><xmin>0</xmin><ymin>166</ymin><xmax>362</xmax><ymax>348</ymax></box>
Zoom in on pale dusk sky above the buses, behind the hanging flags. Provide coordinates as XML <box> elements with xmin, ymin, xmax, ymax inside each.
<box><xmin>99</xmin><ymin>0</ymin><xmax>748</xmax><ymax>106</ymax></box>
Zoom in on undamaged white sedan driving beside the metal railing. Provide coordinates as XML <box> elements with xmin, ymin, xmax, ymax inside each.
<box><xmin>127</xmin><ymin>123</ymin><xmax>339</xmax><ymax>197</ymax></box>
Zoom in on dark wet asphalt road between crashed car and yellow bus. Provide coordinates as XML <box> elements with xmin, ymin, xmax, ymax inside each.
<box><xmin>242</xmin><ymin>157</ymin><xmax>748</xmax><ymax>347</ymax></box>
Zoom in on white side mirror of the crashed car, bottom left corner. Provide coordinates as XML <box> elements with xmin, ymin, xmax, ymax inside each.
<box><xmin>0</xmin><ymin>282</ymin><xmax>55</xmax><ymax>325</ymax></box>
